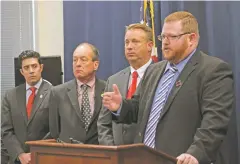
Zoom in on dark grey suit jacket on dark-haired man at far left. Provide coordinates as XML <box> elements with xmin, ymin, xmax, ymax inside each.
<box><xmin>1</xmin><ymin>80</ymin><xmax>52</xmax><ymax>162</ymax></box>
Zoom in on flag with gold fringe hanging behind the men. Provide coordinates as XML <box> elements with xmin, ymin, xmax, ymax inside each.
<box><xmin>140</xmin><ymin>0</ymin><xmax>158</xmax><ymax>62</ymax></box>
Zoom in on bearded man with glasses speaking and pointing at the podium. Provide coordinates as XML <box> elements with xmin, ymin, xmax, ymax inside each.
<box><xmin>103</xmin><ymin>11</ymin><xmax>234</xmax><ymax>164</ymax></box>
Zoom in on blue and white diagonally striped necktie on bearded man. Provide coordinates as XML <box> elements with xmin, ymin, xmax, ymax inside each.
<box><xmin>144</xmin><ymin>67</ymin><xmax>177</xmax><ymax>148</ymax></box>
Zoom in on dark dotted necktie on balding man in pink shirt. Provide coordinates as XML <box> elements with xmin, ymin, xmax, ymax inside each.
<box><xmin>81</xmin><ymin>84</ymin><xmax>92</xmax><ymax>131</ymax></box>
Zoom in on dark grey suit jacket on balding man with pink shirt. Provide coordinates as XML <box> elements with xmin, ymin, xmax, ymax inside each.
<box><xmin>49</xmin><ymin>78</ymin><xmax>105</xmax><ymax>144</ymax></box>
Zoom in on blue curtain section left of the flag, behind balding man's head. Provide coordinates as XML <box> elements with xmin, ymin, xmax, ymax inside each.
<box><xmin>63</xmin><ymin>1</ymin><xmax>141</xmax><ymax>81</ymax></box>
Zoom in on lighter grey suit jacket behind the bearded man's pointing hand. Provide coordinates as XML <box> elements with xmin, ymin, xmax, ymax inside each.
<box><xmin>98</xmin><ymin>67</ymin><xmax>139</xmax><ymax>145</ymax></box>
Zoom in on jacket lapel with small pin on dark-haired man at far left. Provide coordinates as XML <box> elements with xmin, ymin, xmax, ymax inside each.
<box><xmin>28</xmin><ymin>80</ymin><xmax>49</xmax><ymax>125</ymax></box>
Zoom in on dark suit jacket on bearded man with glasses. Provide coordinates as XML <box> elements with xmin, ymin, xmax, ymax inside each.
<box><xmin>114</xmin><ymin>51</ymin><xmax>234</xmax><ymax>164</ymax></box>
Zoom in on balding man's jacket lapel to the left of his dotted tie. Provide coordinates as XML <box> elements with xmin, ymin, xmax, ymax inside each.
<box><xmin>67</xmin><ymin>79</ymin><xmax>82</xmax><ymax>119</ymax></box>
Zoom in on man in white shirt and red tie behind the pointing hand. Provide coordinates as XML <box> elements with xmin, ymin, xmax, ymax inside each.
<box><xmin>98</xmin><ymin>23</ymin><xmax>153</xmax><ymax>145</ymax></box>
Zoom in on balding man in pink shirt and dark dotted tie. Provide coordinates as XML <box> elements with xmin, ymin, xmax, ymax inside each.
<box><xmin>49</xmin><ymin>43</ymin><xmax>105</xmax><ymax>144</ymax></box>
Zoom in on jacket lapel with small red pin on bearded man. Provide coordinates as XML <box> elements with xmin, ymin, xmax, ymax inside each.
<box><xmin>160</xmin><ymin>53</ymin><xmax>199</xmax><ymax>119</ymax></box>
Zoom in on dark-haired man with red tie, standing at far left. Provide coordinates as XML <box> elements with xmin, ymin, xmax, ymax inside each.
<box><xmin>1</xmin><ymin>50</ymin><xmax>52</xmax><ymax>164</ymax></box>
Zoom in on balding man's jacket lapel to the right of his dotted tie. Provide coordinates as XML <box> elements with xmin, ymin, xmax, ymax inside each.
<box><xmin>90</xmin><ymin>78</ymin><xmax>105</xmax><ymax>124</ymax></box>
